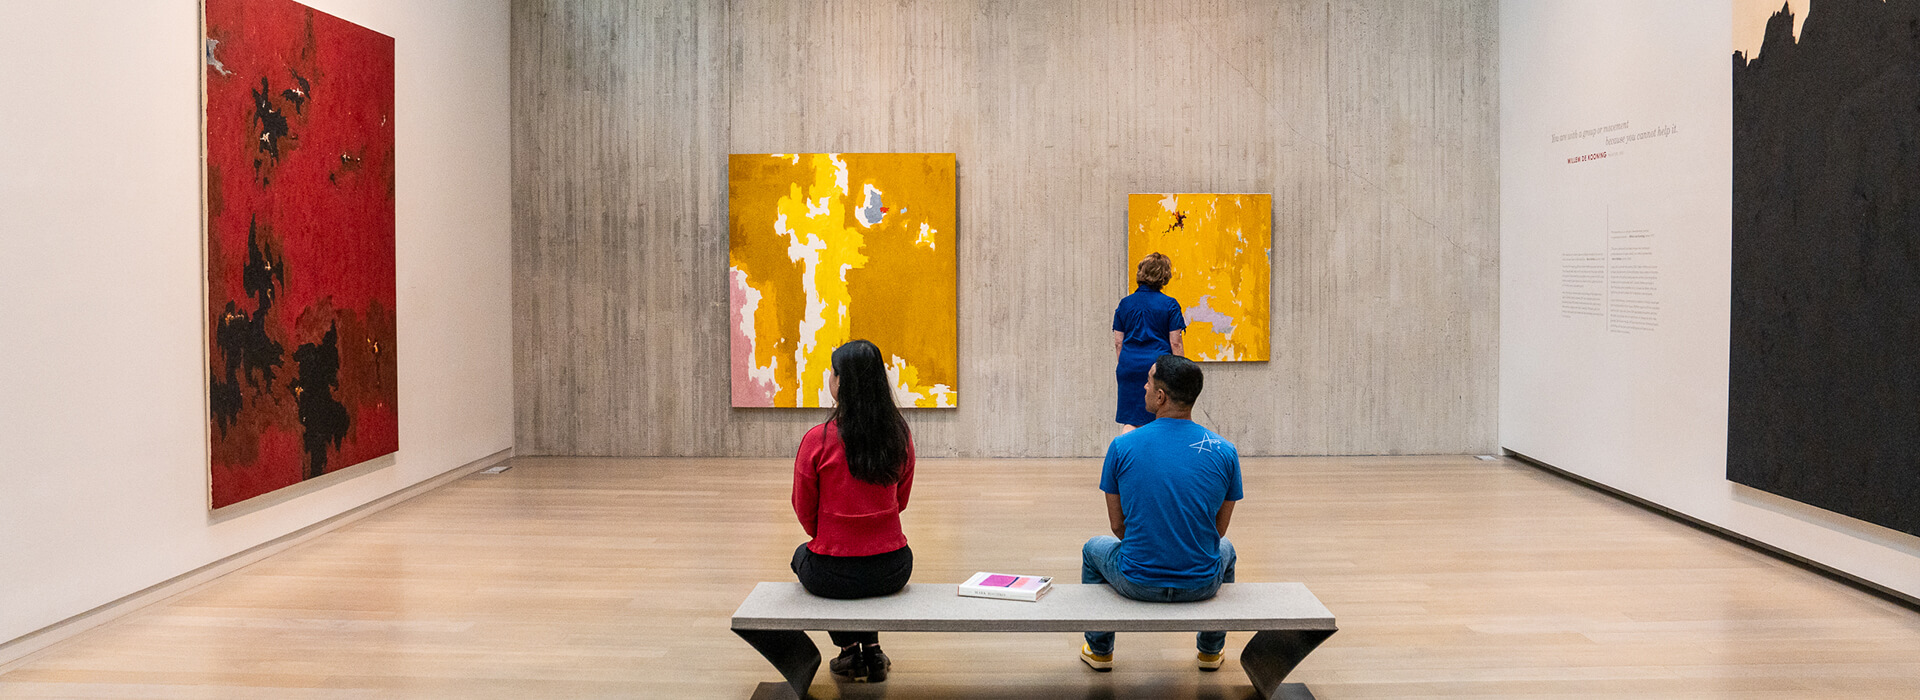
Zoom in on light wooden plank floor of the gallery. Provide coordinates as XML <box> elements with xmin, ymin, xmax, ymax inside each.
<box><xmin>0</xmin><ymin>456</ymin><xmax>1920</xmax><ymax>700</ymax></box>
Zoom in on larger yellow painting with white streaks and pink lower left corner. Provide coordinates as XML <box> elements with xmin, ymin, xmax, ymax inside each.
<box><xmin>728</xmin><ymin>153</ymin><xmax>960</xmax><ymax>402</ymax></box>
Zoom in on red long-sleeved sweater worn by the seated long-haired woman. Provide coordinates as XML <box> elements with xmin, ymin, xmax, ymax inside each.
<box><xmin>793</xmin><ymin>420</ymin><xmax>914</xmax><ymax>556</ymax></box>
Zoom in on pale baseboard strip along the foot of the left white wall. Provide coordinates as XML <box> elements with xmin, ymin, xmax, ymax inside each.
<box><xmin>0</xmin><ymin>447</ymin><xmax>513</xmax><ymax>673</ymax></box>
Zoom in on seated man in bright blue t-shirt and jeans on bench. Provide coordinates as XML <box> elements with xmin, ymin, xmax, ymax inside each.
<box><xmin>1081</xmin><ymin>355</ymin><xmax>1240</xmax><ymax>671</ymax></box>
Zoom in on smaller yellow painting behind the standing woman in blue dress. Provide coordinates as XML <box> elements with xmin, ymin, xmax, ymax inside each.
<box><xmin>1127</xmin><ymin>194</ymin><xmax>1273</xmax><ymax>362</ymax></box>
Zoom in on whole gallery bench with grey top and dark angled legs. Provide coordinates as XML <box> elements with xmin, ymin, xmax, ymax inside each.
<box><xmin>733</xmin><ymin>583</ymin><xmax>1338</xmax><ymax>698</ymax></box>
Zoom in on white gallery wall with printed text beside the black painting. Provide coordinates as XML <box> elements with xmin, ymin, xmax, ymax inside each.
<box><xmin>1500</xmin><ymin>0</ymin><xmax>1920</xmax><ymax>596</ymax></box>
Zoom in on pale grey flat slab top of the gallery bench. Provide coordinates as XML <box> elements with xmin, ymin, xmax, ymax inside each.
<box><xmin>733</xmin><ymin>583</ymin><xmax>1336</xmax><ymax>633</ymax></box>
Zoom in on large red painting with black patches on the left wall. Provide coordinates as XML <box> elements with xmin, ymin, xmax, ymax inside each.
<box><xmin>205</xmin><ymin>0</ymin><xmax>399</xmax><ymax>508</ymax></box>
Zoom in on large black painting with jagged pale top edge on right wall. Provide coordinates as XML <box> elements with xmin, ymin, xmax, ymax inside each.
<box><xmin>1726</xmin><ymin>0</ymin><xmax>1920</xmax><ymax>535</ymax></box>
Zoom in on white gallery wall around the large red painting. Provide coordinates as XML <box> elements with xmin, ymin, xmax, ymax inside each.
<box><xmin>0</xmin><ymin>0</ymin><xmax>513</xmax><ymax>644</ymax></box>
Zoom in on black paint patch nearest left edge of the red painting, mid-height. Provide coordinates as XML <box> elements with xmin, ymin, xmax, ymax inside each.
<box><xmin>209</xmin><ymin>221</ymin><xmax>286</xmax><ymax>435</ymax></box>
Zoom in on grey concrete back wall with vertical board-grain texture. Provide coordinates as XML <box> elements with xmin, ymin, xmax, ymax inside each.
<box><xmin>513</xmin><ymin>0</ymin><xmax>1500</xmax><ymax>456</ymax></box>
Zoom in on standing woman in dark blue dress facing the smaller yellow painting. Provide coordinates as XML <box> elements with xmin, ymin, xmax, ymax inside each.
<box><xmin>1114</xmin><ymin>253</ymin><xmax>1187</xmax><ymax>425</ymax></box>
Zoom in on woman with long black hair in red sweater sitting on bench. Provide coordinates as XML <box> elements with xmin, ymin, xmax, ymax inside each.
<box><xmin>793</xmin><ymin>339</ymin><xmax>914</xmax><ymax>683</ymax></box>
